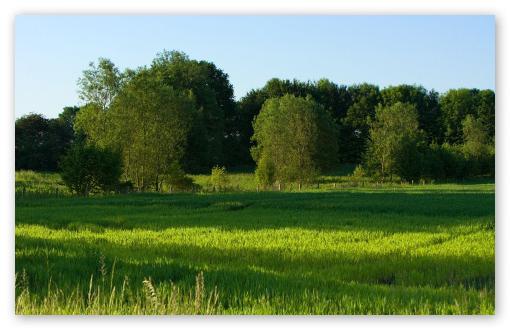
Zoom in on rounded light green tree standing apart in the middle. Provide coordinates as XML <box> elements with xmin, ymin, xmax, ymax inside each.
<box><xmin>252</xmin><ymin>95</ymin><xmax>338</xmax><ymax>184</ymax></box>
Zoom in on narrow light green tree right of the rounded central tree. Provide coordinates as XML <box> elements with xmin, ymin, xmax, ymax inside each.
<box><xmin>367</xmin><ymin>102</ymin><xmax>420</xmax><ymax>179</ymax></box>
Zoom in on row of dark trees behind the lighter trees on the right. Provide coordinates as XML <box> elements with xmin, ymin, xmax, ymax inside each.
<box><xmin>237</xmin><ymin>79</ymin><xmax>495</xmax><ymax>163</ymax></box>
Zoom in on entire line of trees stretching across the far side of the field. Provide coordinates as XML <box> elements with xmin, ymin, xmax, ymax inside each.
<box><xmin>16</xmin><ymin>51</ymin><xmax>495</xmax><ymax>195</ymax></box>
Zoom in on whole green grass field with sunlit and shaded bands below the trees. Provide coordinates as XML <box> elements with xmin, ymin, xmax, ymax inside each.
<box><xmin>16</xmin><ymin>174</ymin><xmax>495</xmax><ymax>314</ymax></box>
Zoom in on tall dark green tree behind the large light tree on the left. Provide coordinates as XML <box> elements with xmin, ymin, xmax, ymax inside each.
<box><xmin>151</xmin><ymin>51</ymin><xmax>234</xmax><ymax>172</ymax></box>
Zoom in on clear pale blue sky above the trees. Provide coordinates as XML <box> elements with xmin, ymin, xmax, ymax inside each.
<box><xmin>15</xmin><ymin>15</ymin><xmax>495</xmax><ymax>118</ymax></box>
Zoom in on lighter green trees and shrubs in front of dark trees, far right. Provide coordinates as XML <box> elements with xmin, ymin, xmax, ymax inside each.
<box><xmin>364</xmin><ymin>102</ymin><xmax>495</xmax><ymax>181</ymax></box>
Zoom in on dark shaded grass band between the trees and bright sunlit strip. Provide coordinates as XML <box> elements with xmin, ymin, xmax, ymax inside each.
<box><xmin>16</xmin><ymin>191</ymin><xmax>495</xmax><ymax>233</ymax></box>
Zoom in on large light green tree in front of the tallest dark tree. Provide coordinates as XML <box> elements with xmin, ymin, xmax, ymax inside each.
<box><xmin>109</xmin><ymin>69</ymin><xmax>197</xmax><ymax>190</ymax></box>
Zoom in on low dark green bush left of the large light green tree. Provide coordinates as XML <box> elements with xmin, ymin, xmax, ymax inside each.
<box><xmin>60</xmin><ymin>143</ymin><xmax>122</xmax><ymax>196</ymax></box>
